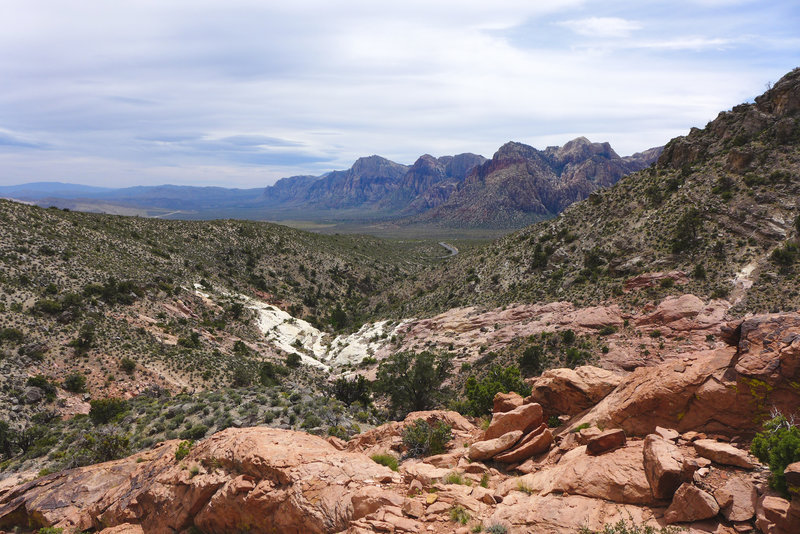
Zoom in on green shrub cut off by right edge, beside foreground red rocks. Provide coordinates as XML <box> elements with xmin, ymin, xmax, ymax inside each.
<box><xmin>750</xmin><ymin>411</ymin><xmax>800</xmax><ymax>497</ymax></box>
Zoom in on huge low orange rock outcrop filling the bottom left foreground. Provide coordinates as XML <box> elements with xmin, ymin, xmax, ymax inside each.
<box><xmin>0</xmin><ymin>427</ymin><xmax>402</xmax><ymax>534</ymax></box>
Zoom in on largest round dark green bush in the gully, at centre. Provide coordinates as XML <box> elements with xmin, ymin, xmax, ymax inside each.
<box><xmin>373</xmin><ymin>352</ymin><xmax>453</xmax><ymax>416</ymax></box>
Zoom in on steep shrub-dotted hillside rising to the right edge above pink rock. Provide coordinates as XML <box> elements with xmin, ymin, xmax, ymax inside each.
<box><xmin>409</xmin><ymin>70</ymin><xmax>800</xmax><ymax>314</ymax></box>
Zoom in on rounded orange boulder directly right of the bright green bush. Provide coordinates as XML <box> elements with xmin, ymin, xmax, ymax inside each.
<box><xmin>525</xmin><ymin>365</ymin><xmax>622</xmax><ymax>415</ymax></box>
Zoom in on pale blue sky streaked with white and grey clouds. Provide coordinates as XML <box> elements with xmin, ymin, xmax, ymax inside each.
<box><xmin>0</xmin><ymin>0</ymin><xmax>800</xmax><ymax>187</ymax></box>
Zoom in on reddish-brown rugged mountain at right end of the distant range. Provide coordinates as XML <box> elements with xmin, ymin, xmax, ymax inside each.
<box><xmin>412</xmin><ymin>137</ymin><xmax>658</xmax><ymax>227</ymax></box>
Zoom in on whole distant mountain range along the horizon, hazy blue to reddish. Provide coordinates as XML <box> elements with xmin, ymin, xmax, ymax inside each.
<box><xmin>0</xmin><ymin>137</ymin><xmax>661</xmax><ymax>228</ymax></box>
